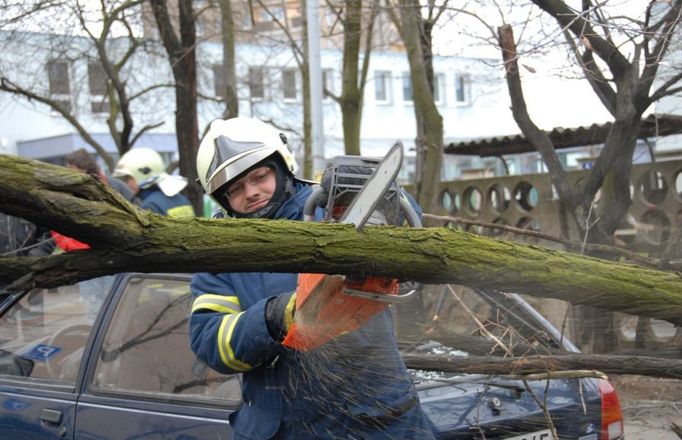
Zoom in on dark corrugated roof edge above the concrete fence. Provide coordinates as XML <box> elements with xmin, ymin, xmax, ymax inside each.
<box><xmin>444</xmin><ymin>115</ymin><xmax>682</xmax><ymax>157</ymax></box>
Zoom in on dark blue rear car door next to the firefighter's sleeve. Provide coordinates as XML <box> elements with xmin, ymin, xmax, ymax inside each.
<box><xmin>76</xmin><ymin>275</ymin><xmax>241</xmax><ymax>440</ymax></box>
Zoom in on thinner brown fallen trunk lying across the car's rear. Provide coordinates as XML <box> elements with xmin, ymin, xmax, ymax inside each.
<box><xmin>403</xmin><ymin>354</ymin><xmax>682</xmax><ymax>379</ymax></box>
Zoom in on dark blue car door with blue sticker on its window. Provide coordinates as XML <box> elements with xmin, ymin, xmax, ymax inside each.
<box><xmin>0</xmin><ymin>277</ymin><xmax>114</xmax><ymax>440</ymax></box>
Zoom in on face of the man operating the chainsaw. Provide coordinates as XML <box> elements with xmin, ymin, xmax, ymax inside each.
<box><xmin>225</xmin><ymin>167</ymin><xmax>277</xmax><ymax>214</ymax></box>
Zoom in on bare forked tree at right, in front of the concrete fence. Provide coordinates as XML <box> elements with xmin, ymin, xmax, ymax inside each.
<box><xmin>499</xmin><ymin>0</ymin><xmax>682</xmax><ymax>242</ymax></box>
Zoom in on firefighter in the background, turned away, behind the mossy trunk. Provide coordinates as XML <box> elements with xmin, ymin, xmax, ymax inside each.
<box><xmin>114</xmin><ymin>148</ymin><xmax>194</xmax><ymax>218</ymax></box>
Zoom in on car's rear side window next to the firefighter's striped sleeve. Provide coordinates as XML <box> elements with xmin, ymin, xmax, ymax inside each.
<box><xmin>93</xmin><ymin>277</ymin><xmax>241</xmax><ymax>402</ymax></box>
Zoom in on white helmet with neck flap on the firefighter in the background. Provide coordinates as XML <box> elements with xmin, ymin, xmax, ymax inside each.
<box><xmin>114</xmin><ymin>148</ymin><xmax>187</xmax><ymax>197</ymax></box>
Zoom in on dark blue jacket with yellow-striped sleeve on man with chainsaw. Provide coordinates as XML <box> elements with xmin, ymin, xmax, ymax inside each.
<box><xmin>190</xmin><ymin>182</ymin><xmax>433</xmax><ymax>440</ymax></box>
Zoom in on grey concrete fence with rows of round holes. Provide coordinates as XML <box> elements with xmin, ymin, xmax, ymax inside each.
<box><xmin>424</xmin><ymin>161</ymin><xmax>682</xmax><ymax>351</ymax></box>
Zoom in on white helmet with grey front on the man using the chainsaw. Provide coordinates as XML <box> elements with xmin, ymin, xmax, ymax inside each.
<box><xmin>197</xmin><ymin>117</ymin><xmax>298</xmax><ymax>212</ymax></box>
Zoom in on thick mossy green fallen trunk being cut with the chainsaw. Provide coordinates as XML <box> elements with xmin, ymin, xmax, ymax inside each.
<box><xmin>0</xmin><ymin>156</ymin><xmax>682</xmax><ymax>325</ymax></box>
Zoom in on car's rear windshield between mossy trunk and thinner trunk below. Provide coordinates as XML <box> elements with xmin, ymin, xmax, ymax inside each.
<box><xmin>393</xmin><ymin>284</ymin><xmax>570</xmax><ymax>380</ymax></box>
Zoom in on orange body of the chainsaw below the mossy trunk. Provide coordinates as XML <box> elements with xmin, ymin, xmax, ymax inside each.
<box><xmin>284</xmin><ymin>273</ymin><xmax>398</xmax><ymax>351</ymax></box>
